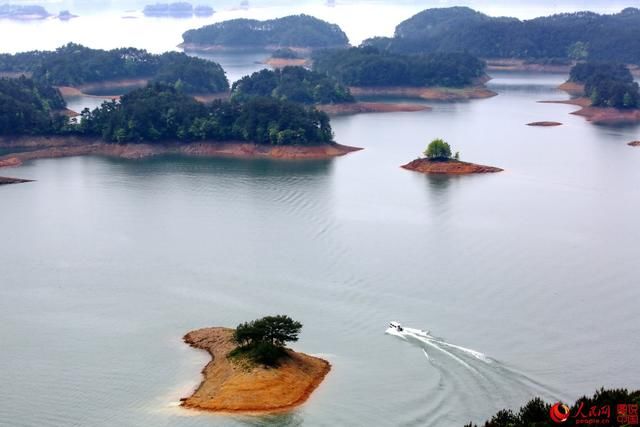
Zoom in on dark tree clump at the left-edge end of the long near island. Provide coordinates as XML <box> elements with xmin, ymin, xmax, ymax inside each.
<box><xmin>0</xmin><ymin>77</ymin><xmax>66</xmax><ymax>135</ymax></box>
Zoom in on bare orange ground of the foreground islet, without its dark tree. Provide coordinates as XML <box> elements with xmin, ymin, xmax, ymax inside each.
<box><xmin>181</xmin><ymin>328</ymin><xmax>331</xmax><ymax>415</ymax></box>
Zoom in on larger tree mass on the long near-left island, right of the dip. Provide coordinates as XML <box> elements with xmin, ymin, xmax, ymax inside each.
<box><xmin>75</xmin><ymin>83</ymin><xmax>333</xmax><ymax>145</ymax></box>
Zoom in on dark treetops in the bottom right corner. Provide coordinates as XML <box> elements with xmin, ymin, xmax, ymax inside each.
<box><xmin>465</xmin><ymin>388</ymin><xmax>640</xmax><ymax>427</ymax></box>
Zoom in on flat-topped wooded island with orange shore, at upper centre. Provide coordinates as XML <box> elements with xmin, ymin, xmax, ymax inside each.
<box><xmin>313</xmin><ymin>46</ymin><xmax>496</xmax><ymax>101</ymax></box>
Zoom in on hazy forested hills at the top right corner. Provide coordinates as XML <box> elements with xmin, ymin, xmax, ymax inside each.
<box><xmin>365</xmin><ymin>7</ymin><xmax>640</xmax><ymax>64</ymax></box>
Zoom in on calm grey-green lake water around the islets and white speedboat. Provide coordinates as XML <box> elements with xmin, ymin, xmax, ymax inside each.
<box><xmin>0</xmin><ymin>5</ymin><xmax>640</xmax><ymax>427</ymax></box>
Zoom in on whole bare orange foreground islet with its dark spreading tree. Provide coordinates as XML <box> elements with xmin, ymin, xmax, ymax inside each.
<box><xmin>181</xmin><ymin>316</ymin><xmax>331</xmax><ymax>414</ymax></box>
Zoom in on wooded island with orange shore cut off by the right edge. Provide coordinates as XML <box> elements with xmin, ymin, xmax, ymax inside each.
<box><xmin>544</xmin><ymin>62</ymin><xmax>640</xmax><ymax>124</ymax></box>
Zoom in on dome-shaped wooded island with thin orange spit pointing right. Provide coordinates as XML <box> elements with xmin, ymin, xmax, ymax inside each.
<box><xmin>231</xmin><ymin>66</ymin><xmax>429</xmax><ymax>115</ymax></box>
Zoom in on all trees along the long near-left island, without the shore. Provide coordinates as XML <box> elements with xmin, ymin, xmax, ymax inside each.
<box><xmin>0</xmin><ymin>77</ymin><xmax>333</xmax><ymax>145</ymax></box>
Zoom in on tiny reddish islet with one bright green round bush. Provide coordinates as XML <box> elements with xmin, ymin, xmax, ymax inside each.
<box><xmin>402</xmin><ymin>139</ymin><xmax>503</xmax><ymax>175</ymax></box>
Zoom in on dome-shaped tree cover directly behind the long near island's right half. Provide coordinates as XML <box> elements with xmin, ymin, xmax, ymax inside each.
<box><xmin>231</xmin><ymin>67</ymin><xmax>355</xmax><ymax>104</ymax></box>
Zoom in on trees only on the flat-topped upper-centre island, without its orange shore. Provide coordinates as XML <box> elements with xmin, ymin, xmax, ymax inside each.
<box><xmin>313</xmin><ymin>46</ymin><xmax>485</xmax><ymax>87</ymax></box>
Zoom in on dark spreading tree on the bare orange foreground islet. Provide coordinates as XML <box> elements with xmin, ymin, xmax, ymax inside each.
<box><xmin>229</xmin><ymin>315</ymin><xmax>302</xmax><ymax>366</ymax></box>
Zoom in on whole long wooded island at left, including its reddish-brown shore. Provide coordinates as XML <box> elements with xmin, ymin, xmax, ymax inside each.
<box><xmin>0</xmin><ymin>77</ymin><xmax>359</xmax><ymax>178</ymax></box>
